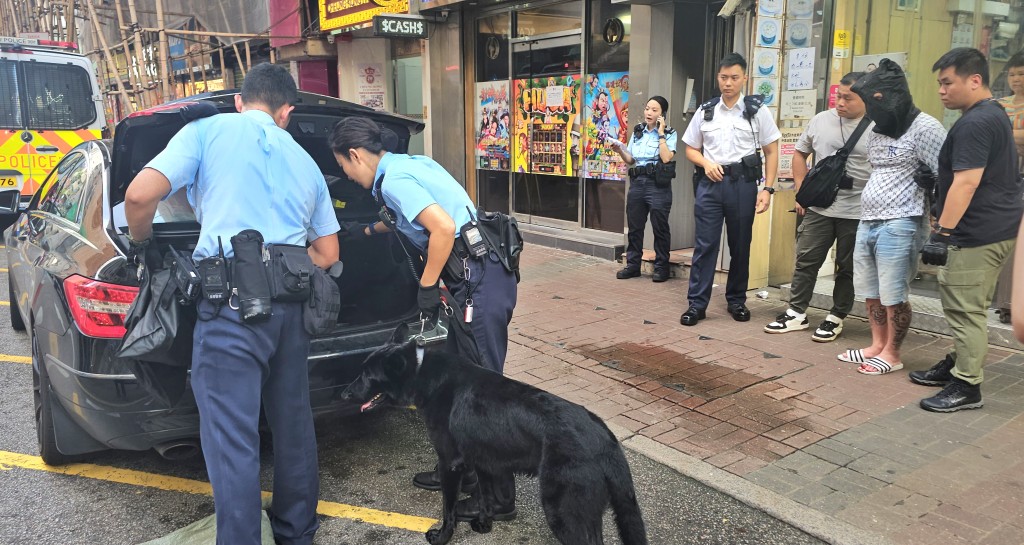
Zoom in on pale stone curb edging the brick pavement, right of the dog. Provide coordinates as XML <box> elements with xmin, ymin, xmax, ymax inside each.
<box><xmin>605</xmin><ymin>422</ymin><xmax>894</xmax><ymax>545</ymax></box>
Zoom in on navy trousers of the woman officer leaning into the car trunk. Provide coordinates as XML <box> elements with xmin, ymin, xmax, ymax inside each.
<box><xmin>444</xmin><ymin>253</ymin><xmax>518</xmax><ymax>373</ymax></box>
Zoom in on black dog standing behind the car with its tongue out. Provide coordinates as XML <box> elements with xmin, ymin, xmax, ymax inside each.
<box><xmin>346</xmin><ymin>341</ymin><xmax>647</xmax><ymax>545</ymax></box>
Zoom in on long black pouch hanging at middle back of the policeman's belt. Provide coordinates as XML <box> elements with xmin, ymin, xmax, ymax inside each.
<box><xmin>231</xmin><ymin>229</ymin><xmax>270</xmax><ymax>324</ymax></box>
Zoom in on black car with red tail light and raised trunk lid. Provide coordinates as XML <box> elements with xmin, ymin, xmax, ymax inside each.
<box><xmin>0</xmin><ymin>91</ymin><xmax>432</xmax><ymax>464</ymax></box>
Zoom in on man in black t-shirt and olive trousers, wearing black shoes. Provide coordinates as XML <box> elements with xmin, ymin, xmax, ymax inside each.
<box><xmin>910</xmin><ymin>47</ymin><xmax>1024</xmax><ymax>413</ymax></box>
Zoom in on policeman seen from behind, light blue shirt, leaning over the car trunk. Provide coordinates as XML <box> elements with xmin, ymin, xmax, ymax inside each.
<box><xmin>125</xmin><ymin>64</ymin><xmax>339</xmax><ymax>545</ymax></box>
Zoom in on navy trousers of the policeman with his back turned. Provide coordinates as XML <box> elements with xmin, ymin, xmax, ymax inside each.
<box><xmin>191</xmin><ymin>300</ymin><xmax>319</xmax><ymax>545</ymax></box>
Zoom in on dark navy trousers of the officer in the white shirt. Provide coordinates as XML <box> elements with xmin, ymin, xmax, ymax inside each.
<box><xmin>686</xmin><ymin>174</ymin><xmax>758</xmax><ymax>308</ymax></box>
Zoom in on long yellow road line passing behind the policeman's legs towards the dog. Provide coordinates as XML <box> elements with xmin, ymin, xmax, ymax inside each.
<box><xmin>0</xmin><ymin>451</ymin><xmax>437</xmax><ymax>532</ymax></box>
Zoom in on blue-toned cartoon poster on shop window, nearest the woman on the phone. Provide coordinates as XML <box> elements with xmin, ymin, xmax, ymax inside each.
<box><xmin>584</xmin><ymin>72</ymin><xmax>630</xmax><ymax>180</ymax></box>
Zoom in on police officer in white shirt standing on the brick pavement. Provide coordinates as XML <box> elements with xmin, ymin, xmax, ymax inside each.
<box><xmin>679</xmin><ymin>53</ymin><xmax>782</xmax><ymax>326</ymax></box>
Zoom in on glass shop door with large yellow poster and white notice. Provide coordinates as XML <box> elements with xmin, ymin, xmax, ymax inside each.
<box><xmin>509</xmin><ymin>31</ymin><xmax>583</xmax><ymax>228</ymax></box>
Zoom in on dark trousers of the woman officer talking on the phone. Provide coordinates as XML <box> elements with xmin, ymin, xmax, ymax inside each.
<box><xmin>626</xmin><ymin>175</ymin><xmax>672</xmax><ymax>271</ymax></box>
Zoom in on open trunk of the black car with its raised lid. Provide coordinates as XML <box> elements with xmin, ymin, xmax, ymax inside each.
<box><xmin>110</xmin><ymin>92</ymin><xmax>423</xmax><ymax>332</ymax></box>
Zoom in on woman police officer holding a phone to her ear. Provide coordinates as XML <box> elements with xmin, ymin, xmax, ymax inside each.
<box><xmin>608</xmin><ymin>96</ymin><xmax>676</xmax><ymax>282</ymax></box>
